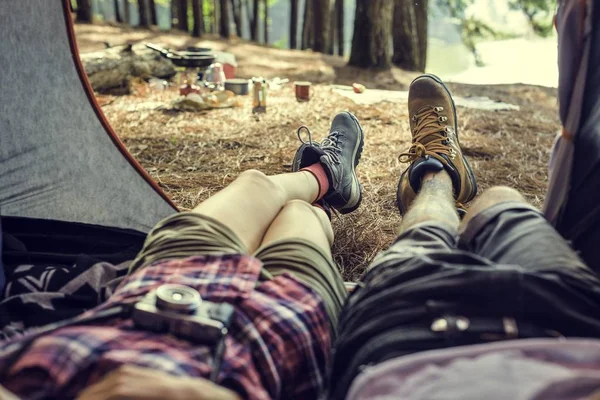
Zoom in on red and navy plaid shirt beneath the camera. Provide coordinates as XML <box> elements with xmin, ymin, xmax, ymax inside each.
<box><xmin>0</xmin><ymin>255</ymin><xmax>330</xmax><ymax>399</ymax></box>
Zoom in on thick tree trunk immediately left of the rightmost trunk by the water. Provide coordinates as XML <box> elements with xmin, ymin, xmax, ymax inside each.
<box><xmin>348</xmin><ymin>0</ymin><xmax>394</xmax><ymax>69</ymax></box>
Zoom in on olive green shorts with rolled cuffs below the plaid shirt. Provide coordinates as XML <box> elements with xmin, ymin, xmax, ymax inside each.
<box><xmin>129</xmin><ymin>212</ymin><xmax>346</xmax><ymax>333</ymax></box>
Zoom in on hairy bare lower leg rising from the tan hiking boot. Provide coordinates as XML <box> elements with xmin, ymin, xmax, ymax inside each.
<box><xmin>400</xmin><ymin>171</ymin><xmax>460</xmax><ymax>233</ymax></box>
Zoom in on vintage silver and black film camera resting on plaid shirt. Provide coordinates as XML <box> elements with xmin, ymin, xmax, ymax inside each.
<box><xmin>132</xmin><ymin>284</ymin><xmax>234</xmax><ymax>345</ymax></box>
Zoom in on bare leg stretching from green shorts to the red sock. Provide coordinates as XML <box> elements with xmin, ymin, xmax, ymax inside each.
<box><xmin>193</xmin><ymin>170</ymin><xmax>319</xmax><ymax>253</ymax></box>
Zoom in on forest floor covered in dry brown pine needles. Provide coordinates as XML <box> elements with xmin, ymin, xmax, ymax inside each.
<box><xmin>76</xmin><ymin>25</ymin><xmax>559</xmax><ymax>280</ymax></box>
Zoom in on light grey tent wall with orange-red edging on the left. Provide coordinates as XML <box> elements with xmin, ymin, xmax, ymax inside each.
<box><xmin>0</xmin><ymin>0</ymin><xmax>177</xmax><ymax>233</ymax></box>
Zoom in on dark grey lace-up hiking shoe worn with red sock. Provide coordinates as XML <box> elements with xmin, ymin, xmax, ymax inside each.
<box><xmin>292</xmin><ymin>112</ymin><xmax>364</xmax><ymax>214</ymax></box>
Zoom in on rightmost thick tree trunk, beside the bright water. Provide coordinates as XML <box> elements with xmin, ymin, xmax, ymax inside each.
<box><xmin>392</xmin><ymin>0</ymin><xmax>428</xmax><ymax>72</ymax></box>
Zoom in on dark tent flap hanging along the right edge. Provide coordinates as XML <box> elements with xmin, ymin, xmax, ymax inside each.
<box><xmin>544</xmin><ymin>0</ymin><xmax>600</xmax><ymax>272</ymax></box>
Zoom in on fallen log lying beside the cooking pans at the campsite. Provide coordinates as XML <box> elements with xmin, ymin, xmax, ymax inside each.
<box><xmin>81</xmin><ymin>44</ymin><xmax>176</xmax><ymax>92</ymax></box>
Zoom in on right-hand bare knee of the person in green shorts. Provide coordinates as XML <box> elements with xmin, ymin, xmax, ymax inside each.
<box><xmin>261</xmin><ymin>200</ymin><xmax>333</xmax><ymax>256</ymax></box>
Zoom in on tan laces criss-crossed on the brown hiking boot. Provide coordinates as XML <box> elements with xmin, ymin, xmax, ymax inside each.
<box><xmin>398</xmin><ymin>106</ymin><xmax>456</xmax><ymax>164</ymax></box>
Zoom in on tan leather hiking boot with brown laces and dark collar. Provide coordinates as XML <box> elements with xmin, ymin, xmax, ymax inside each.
<box><xmin>397</xmin><ymin>74</ymin><xmax>477</xmax><ymax>215</ymax></box>
